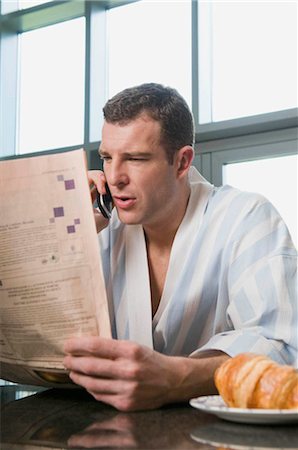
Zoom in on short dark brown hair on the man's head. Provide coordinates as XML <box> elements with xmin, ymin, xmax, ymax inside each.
<box><xmin>103</xmin><ymin>83</ymin><xmax>194</xmax><ymax>164</ymax></box>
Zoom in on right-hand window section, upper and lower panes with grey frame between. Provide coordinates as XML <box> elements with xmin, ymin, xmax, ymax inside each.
<box><xmin>196</xmin><ymin>0</ymin><xmax>298</xmax><ymax>250</ymax></box>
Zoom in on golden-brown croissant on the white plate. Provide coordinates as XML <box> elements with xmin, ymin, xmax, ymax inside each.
<box><xmin>214</xmin><ymin>353</ymin><xmax>298</xmax><ymax>409</ymax></box>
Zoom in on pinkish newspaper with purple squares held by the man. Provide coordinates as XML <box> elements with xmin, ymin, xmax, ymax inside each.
<box><xmin>0</xmin><ymin>150</ymin><xmax>111</xmax><ymax>387</ymax></box>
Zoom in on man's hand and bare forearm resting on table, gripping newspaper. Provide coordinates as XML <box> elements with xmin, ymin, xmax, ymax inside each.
<box><xmin>64</xmin><ymin>337</ymin><xmax>228</xmax><ymax>411</ymax></box>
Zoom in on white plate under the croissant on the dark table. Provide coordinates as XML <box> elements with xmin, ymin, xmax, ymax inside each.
<box><xmin>189</xmin><ymin>395</ymin><xmax>298</xmax><ymax>423</ymax></box>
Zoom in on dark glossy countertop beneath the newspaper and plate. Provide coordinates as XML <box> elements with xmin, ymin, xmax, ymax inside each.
<box><xmin>0</xmin><ymin>385</ymin><xmax>298</xmax><ymax>450</ymax></box>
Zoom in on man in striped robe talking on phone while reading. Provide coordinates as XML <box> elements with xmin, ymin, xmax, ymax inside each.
<box><xmin>65</xmin><ymin>84</ymin><xmax>297</xmax><ymax>411</ymax></box>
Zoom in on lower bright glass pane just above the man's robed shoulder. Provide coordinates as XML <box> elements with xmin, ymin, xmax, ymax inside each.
<box><xmin>223</xmin><ymin>155</ymin><xmax>298</xmax><ymax>247</ymax></box>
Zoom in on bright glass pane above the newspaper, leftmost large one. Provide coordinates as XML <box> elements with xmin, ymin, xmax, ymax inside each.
<box><xmin>19</xmin><ymin>18</ymin><xmax>85</xmax><ymax>153</ymax></box>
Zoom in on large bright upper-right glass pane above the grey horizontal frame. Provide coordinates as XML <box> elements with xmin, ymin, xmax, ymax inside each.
<box><xmin>199</xmin><ymin>1</ymin><xmax>298</xmax><ymax>123</ymax></box>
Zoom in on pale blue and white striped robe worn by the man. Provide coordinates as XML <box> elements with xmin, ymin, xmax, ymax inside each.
<box><xmin>99</xmin><ymin>167</ymin><xmax>298</xmax><ymax>366</ymax></box>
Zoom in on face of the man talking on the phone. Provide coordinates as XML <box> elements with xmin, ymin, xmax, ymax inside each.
<box><xmin>100</xmin><ymin>115</ymin><xmax>177</xmax><ymax>226</ymax></box>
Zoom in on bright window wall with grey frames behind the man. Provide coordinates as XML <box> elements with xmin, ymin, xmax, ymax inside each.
<box><xmin>0</xmin><ymin>0</ymin><xmax>298</xmax><ymax>245</ymax></box>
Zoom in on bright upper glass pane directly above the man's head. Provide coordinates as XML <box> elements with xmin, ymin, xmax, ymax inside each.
<box><xmin>107</xmin><ymin>0</ymin><xmax>191</xmax><ymax>106</ymax></box>
